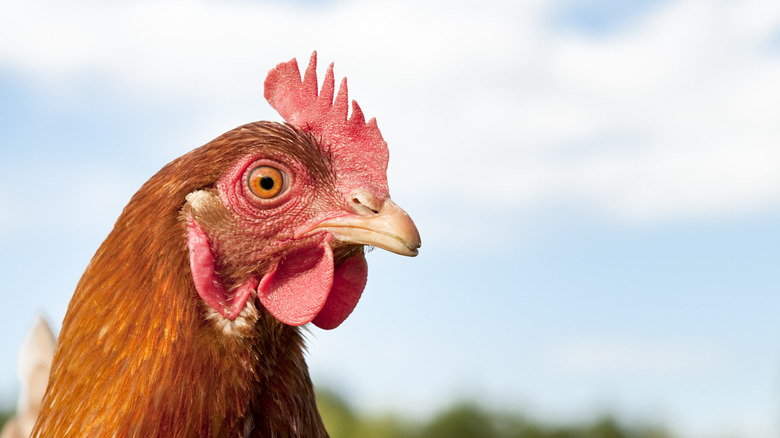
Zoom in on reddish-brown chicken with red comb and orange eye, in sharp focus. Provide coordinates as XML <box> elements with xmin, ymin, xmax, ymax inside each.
<box><xmin>32</xmin><ymin>52</ymin><xmax>420</xmax><ymax>437</ymax></box>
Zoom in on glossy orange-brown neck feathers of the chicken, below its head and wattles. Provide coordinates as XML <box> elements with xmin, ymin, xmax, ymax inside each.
<box><xmin>32</xmin><ymin>150</ymin><xmax>327</xmax><ymax>437</ymax></box>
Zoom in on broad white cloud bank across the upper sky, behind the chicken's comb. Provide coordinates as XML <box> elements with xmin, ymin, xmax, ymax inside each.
<box><xmin>0</xmin><ymin>0</ymin><xmax>780</xmax><ymax>236</ymax></box>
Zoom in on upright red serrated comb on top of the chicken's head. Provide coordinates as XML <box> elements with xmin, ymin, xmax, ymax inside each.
<box><xmin>265</xmin><ymin>52</ymin><xmax>388</xmax><ymax>200</ymax></box>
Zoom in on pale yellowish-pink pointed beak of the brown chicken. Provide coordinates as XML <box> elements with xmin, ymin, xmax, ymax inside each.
<box><xmin>310</xmin><ymin>198</ymin><xmax>421</xmax><ymax>257</ymax></box>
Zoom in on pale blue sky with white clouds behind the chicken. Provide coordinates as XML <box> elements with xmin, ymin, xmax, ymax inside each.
<box><xmin>0</xmin><ymin>0</ymin><xmax>780</xmax><ymax>438</ymax></box>
